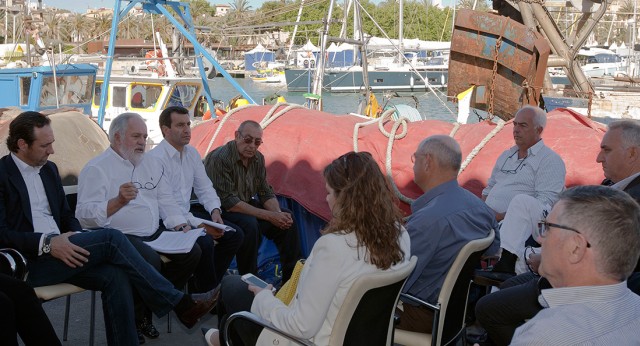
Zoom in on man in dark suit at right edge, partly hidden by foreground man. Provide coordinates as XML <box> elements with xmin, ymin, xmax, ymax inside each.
<box><xmin>476</xmin><ymin>120</ymin><xmax>640</xmax><ymax>345</ymax></box>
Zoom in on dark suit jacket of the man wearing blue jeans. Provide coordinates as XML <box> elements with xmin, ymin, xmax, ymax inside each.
<box><xmin>0</xmin><ymin>155</ymin><xmax>82</xmax><ymax>257</ymax></box>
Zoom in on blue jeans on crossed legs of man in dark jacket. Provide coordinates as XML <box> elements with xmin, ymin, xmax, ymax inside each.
<box><xmin>27</xmin><ymin>229</ymin><xmax>184</xmax><ymax>345</ymax></box>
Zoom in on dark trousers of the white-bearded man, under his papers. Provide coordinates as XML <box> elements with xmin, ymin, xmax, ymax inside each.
<box><xmin>126</xmin><ymin>227</ymin><xmax>201</xmax><ymax>325</ymax></box>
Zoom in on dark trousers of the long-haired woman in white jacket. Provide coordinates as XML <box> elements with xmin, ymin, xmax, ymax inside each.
<box><xmin>218</xmin><ymin>275</ymin><xmax>262</xmax><ymax>346</ymax></box>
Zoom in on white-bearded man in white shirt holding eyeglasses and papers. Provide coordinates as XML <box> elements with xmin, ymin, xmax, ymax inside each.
<box><xmin>76</xmin><ymin>113</ymin><xmax>201</xmax><ymax>342</ymax></box>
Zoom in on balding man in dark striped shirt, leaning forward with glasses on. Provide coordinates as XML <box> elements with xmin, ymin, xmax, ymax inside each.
<box><xmin>204</xmin><ymin>120</ymin><xmax>301</xmax><ymax>282</ymax></box>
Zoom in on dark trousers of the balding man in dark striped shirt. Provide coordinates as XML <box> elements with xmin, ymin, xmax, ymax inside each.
<box><xmin>223</xmin><ymin>208</ymin><xmax>301</xmax><ymax>282</ymax></box>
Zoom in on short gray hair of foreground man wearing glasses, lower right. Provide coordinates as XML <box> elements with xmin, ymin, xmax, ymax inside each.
<box><xmin>559</xmin><ymin>185</ymin><xmax>640</xmax><ymax>281</ymax></box>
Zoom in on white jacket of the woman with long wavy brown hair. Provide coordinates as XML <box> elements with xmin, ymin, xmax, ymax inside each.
<box><xmin>251</xmin><ymin>228</ymin><xmax>411</xmax><ymax>346</ymax></box>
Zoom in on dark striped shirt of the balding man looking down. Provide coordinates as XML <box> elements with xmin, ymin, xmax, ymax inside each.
<box><xmin>204</xmin><ymin>141</ymin><xmax>275</xmax><ymax>210</ymax></box>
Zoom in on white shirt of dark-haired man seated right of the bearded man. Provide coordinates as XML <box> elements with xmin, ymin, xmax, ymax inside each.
<box><xmin>149</xmin><ymin>140</ymin><xmax>220</xmax><ymax>226</ymax></box>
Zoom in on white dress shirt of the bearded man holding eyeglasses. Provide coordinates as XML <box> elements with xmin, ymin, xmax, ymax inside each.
<box><xmin>76</xmin><ymin>147</ymin><xmax>187</xmax><ymax>237</ymax></box>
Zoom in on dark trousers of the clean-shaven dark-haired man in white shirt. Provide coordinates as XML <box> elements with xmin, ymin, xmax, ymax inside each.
<box><xmin>190</xmin><ymin>205</ymin><xmax>244</xmax><ymax>293</ymax></box>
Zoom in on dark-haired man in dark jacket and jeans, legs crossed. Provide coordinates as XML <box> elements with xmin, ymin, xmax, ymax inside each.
<box><xmin>0</xmin><ymin>112</ymin><xmax>217</xmax><ymax>345</ymax></box>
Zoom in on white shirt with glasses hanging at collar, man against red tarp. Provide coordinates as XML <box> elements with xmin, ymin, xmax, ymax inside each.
<box><xmin>482</xmin><ymin>140</ymin><xmax>567</xmax><ymax>213</ymax></box>
